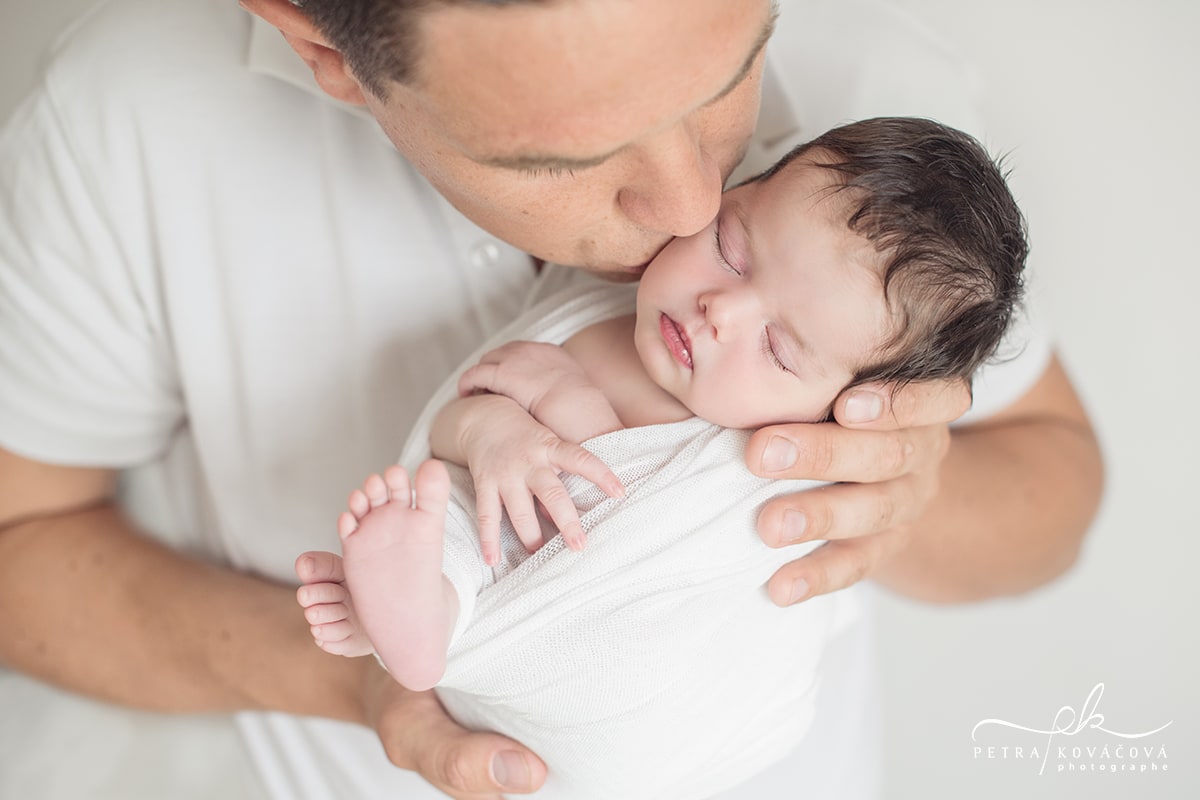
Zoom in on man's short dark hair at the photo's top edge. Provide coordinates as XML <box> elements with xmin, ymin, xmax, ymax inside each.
<box><xmin>295</xmin><ymin>0</ymin><xmax>530</xmax><ymax>100</ymax></box>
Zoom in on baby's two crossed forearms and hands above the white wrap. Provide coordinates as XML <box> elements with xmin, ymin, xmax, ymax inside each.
<box><xmin>431</xmin><ymin>342</ymin><xmax>624</xmax><ymax>565</ymax></box>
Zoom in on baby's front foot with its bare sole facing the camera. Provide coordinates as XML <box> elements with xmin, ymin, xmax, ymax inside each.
<box><xmin>337</xmin><ymin>461</ymin><xmax>452</xmax><ymax>690</ymax></box>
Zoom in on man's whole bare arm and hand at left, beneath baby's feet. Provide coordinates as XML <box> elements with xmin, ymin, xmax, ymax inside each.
<box><xmin>0</xmin><ymin>450</ymin><xmax>546</xmax><ymax>800</ymax></box>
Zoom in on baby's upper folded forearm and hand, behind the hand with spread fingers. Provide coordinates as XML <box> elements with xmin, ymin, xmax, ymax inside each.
<box><xmin>458</xmin><ymin>342</ymin><xmax>623</xmax><ymax>444</ymax></box>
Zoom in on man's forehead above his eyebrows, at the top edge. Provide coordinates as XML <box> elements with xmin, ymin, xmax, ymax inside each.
<box><xmin>408</xmin><ymin>0</ymin><xmax>775</xmax><ymax>168</ymax></box>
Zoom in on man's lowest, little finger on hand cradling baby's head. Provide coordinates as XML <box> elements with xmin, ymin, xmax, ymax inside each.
<box><xmin>767</xmin><ymin>527</ymin><xmax>908</xmax><ymax>606</ymax></box>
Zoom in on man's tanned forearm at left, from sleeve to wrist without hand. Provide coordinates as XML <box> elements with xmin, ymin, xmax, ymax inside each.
<box><xmin>0</xmin><ymin>505</ymin><xmax>365</xmax><ymax>722</ymax></box>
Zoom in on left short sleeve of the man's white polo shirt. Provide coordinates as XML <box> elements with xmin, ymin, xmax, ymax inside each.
<box><xmin>0</xmin><ymin>77</ymin><xmax>184</xmax><ymax>468</ymax></box>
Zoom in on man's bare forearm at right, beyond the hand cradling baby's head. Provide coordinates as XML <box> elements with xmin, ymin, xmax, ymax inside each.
<box><xmin>876</xmin><ymin>362</ymin><xmax>1103</xmax><ymax>602</ymax></box>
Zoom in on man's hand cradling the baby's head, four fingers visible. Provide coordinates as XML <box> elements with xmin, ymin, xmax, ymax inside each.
<box><xmin>746</xmin><ymin>381</ymin><xmax>971</xmax><ymax>606</ymax></box>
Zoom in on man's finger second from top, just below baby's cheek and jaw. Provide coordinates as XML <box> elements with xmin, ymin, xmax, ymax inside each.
<box><xmin>746</xmin><ymin>422</ymin><xmax>949</xmax><ymax>483</ymax></box>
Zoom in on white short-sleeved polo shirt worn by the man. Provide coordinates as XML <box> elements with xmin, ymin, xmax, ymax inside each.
<box><xmin>0</xmin><ymin>0</ymin><xmax>1048</xmax><ymax>800</ymax></box>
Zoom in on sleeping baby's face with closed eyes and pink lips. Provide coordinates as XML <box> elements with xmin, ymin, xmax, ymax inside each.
<box><xmin>635</xmin><ymin>157</ymin><xmax>893</xmax><ymax>428</ymax></box>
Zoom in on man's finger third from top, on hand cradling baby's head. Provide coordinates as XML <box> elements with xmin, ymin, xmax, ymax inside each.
<box><xmin>757</xmin><ymin>475</ymin><xmax>936</xmax><ymax>547</ymax></box>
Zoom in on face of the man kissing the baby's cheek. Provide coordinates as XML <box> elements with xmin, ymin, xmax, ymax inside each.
<box><xmin>357</xmin><ymin>0</ymin><xmax>773</xmax><ymax>276</ymax></box>
